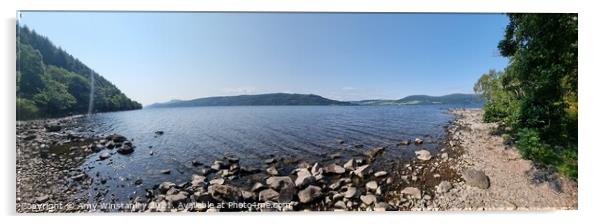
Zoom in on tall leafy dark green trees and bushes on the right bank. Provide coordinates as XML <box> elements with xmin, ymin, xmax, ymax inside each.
<box><xmin>474</xmin><ymin>14</ymin><xmax>578</xmax><ymax>178</ymax></box>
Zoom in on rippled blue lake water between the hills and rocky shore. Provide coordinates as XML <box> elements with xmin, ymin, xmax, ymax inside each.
<box><xmin>75</xmin><ymin>105</ymin><xmax>458</xmax><ymax>202</ymax></box>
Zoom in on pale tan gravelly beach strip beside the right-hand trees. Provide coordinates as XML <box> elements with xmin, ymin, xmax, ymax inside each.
<box><xmin>433</xmin><ymin>109</ymin><xmax>577</xmax><ymax>210</ymax></box>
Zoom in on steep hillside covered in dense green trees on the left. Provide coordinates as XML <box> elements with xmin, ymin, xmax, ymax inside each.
<box><xmin>17</xmin><ymin>25</ymin><xmax>142</xmax><ymax>120</ymax></box>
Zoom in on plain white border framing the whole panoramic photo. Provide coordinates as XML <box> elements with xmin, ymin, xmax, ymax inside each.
<box><xmin>0</xmin><ymin>0</ymin><xmax>602</xmax><ymax>224</ymax></box>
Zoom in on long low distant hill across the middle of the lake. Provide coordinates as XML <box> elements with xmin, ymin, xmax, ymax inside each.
<box><xmin>146</xmin><ymin>93</ymin><xmax>353</xmax><ymax>108</ymax></box>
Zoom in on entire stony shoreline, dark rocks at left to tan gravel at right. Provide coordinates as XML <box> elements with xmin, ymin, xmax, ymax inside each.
<box><xmin>17</xmin><ymin>110</ymin><xmax>577</xmax><ymax>212</ymax></box>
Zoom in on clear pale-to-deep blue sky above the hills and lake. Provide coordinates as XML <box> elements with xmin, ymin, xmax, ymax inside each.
<box><xmin>20</xmin><ymin>12</ymin><xmax>508</xmax><ymax>105</ymax></box>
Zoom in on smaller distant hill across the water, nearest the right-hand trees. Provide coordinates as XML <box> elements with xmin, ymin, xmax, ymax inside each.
<box><xmin>396</xmin><ymin>93</ymin><xmax>483</xmax><ymax>104</ymax></box>
